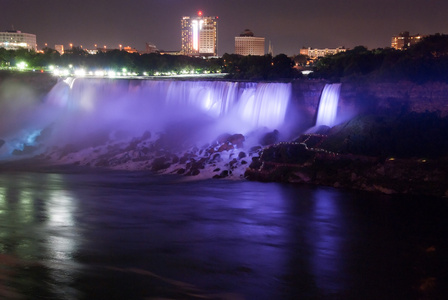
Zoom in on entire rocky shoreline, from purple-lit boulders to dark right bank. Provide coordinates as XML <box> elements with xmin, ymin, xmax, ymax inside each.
<box><xmin>10</xmin><ymin>127</ymin><xmax>448</xmax><ymax>197</ymax></box>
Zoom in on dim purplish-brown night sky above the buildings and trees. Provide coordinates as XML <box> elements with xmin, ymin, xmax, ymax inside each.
<box><xmin>0</xmin><ymin>0</ymin><xmax>448</xmax><ymax>55</ymax></box>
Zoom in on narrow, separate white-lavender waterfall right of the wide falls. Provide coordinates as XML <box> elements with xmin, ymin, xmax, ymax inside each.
<box><xmin>316</xmin><ymin>83</ymin><xmax>341</xmax><ymax>127</ymax></box>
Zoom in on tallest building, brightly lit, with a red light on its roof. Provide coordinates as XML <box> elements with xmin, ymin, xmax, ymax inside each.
<box><xmin>181</xmin><ymin>11</ymin><xmax>218</xmax><ymax>56</ymax></box>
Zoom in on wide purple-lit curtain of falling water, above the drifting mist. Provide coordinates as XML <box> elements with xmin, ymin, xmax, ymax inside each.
<box><xmin>43</xmin><ymin>79</ymin><xmax>291</xmax><ymax>130</ymax></box>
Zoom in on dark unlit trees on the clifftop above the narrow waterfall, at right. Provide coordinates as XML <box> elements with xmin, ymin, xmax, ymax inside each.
<box><xmin>311</xmin><ymin>34</ymin><xmax>448</xmax><ymax>83</ymax></box>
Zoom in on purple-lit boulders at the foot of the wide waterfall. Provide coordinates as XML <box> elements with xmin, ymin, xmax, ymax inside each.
<box><xmin>35</xmin><ymin>132</ymin><xmax>262</xmax><ymax>179</ymax></box>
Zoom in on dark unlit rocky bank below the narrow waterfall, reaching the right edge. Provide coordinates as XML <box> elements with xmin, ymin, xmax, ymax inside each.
<box><xmin>245</xmin><ymin>134</ymin><xmax>448</xmax><ymax>197</ymax></box>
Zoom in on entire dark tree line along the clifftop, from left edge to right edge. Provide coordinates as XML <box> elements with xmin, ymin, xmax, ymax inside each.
<box><xmin>0</xmin><ymin>34</ymin><xmax>448</xmax><ymax>83</ymax></box>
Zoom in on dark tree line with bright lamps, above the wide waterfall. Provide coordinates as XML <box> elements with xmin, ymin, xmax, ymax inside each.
<box><xmin>0</xmin><ymin>47</ymin><xmax>301</xmax><ymax>80</ymax></box>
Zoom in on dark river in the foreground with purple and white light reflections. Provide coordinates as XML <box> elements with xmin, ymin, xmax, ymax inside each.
<box><xmin>0</xmin><ymin>171</ymin><xmax>448</xmax><ymax>299</ymax></box>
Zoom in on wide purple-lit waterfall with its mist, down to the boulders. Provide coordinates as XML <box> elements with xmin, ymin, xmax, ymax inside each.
<box><xmin>0</xmin><ymin>78</ymin><xmax>291</xmax><ymax>156</ymax></box>
